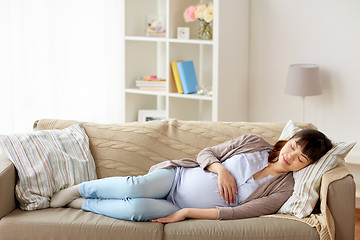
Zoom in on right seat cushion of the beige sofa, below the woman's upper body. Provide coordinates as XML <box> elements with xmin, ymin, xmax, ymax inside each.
<box><xmin>164</xmin><ymin>217</ymin><xmax>319</xmax><ymax>240</ymax></box>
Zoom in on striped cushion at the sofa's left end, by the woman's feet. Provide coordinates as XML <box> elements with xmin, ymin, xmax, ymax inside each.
<box><xmin>0</xmin><ymin>124</ymin><xmax>96</xmax><ymax>210</ymax></box>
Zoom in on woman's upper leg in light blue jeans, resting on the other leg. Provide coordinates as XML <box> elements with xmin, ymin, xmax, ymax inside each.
<box><xmin>80</xmin><ymin>169</ymin><xmax>175</xmax><ymax>199</ymax></box>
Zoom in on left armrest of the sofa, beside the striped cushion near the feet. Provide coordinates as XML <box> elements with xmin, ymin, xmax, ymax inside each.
<box><xmin>0</xmin><ymin>153</ymin><xmax>16</xmax><ymax>219</ymax></box>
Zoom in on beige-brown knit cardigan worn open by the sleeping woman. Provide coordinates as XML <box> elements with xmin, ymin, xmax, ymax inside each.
<box><xmin>150</xmin><ymin>135</ymin><xmax>294</xmax><ymax>219</ymax></box>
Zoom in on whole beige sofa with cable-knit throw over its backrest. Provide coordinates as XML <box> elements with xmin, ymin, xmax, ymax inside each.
<box><xmin>0</xmin><ymin>119</ymin><xmax>355</xmax><ymax>240</ymax></box>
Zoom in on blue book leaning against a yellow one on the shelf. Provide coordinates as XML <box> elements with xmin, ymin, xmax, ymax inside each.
<box><xmin>176</xmin><ymin>61</ymin><xmax>199</xmax><ymax>94</ymax></box>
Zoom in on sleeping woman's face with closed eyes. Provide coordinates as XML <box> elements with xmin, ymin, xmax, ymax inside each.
<box><xmin>278</xmin><ymin>139</ymin><xmax>311</xmax><ymax>172</ymax></box>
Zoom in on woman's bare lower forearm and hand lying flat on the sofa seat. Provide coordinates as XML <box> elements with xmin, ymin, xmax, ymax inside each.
<box><xmin>150</xmin><ymin>208</ymin><xmax>218</xmax><ymax>223</ymax></box>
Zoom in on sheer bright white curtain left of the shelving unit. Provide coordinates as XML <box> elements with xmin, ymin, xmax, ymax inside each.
<box><xmin>0</xmin><ymin>0</ymin><xmax>121</xmax><ymax>134</ymax></box>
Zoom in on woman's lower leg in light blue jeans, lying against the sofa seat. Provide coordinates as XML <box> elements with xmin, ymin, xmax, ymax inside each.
<box><xmin>82</xmin><ymin>198</ymin><xmax>179</xmax><ymax>221</ymax></box>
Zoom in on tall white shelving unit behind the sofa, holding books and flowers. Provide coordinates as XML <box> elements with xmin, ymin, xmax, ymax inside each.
<box><xmin>121</xmin><ymin>0</ymin><xmax>249</xmax><ymax>122</ymax></box>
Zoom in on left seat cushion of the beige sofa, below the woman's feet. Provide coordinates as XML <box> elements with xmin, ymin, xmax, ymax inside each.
<box><xmin>0</xmin><ymin>208</ymin><xmax>163</xmax><ymax>240</ymax></box>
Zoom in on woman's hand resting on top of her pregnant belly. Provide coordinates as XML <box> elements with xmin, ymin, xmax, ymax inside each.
<box><xmin>207</xmin><ymin>162</ymin><xmax>237</xmax><ymax>204</ymax></box>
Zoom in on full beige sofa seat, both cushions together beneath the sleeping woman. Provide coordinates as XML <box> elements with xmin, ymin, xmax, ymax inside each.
<box><xmin>0</xmin><ymin>208</ymin><xmax>319</xmax><ymax>240</ymax></box>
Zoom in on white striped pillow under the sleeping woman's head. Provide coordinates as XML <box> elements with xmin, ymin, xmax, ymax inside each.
<box><xmin>278</xmin><ymin>120</ymin><xmax>356</xmax><ymax>218</ymax></box>
